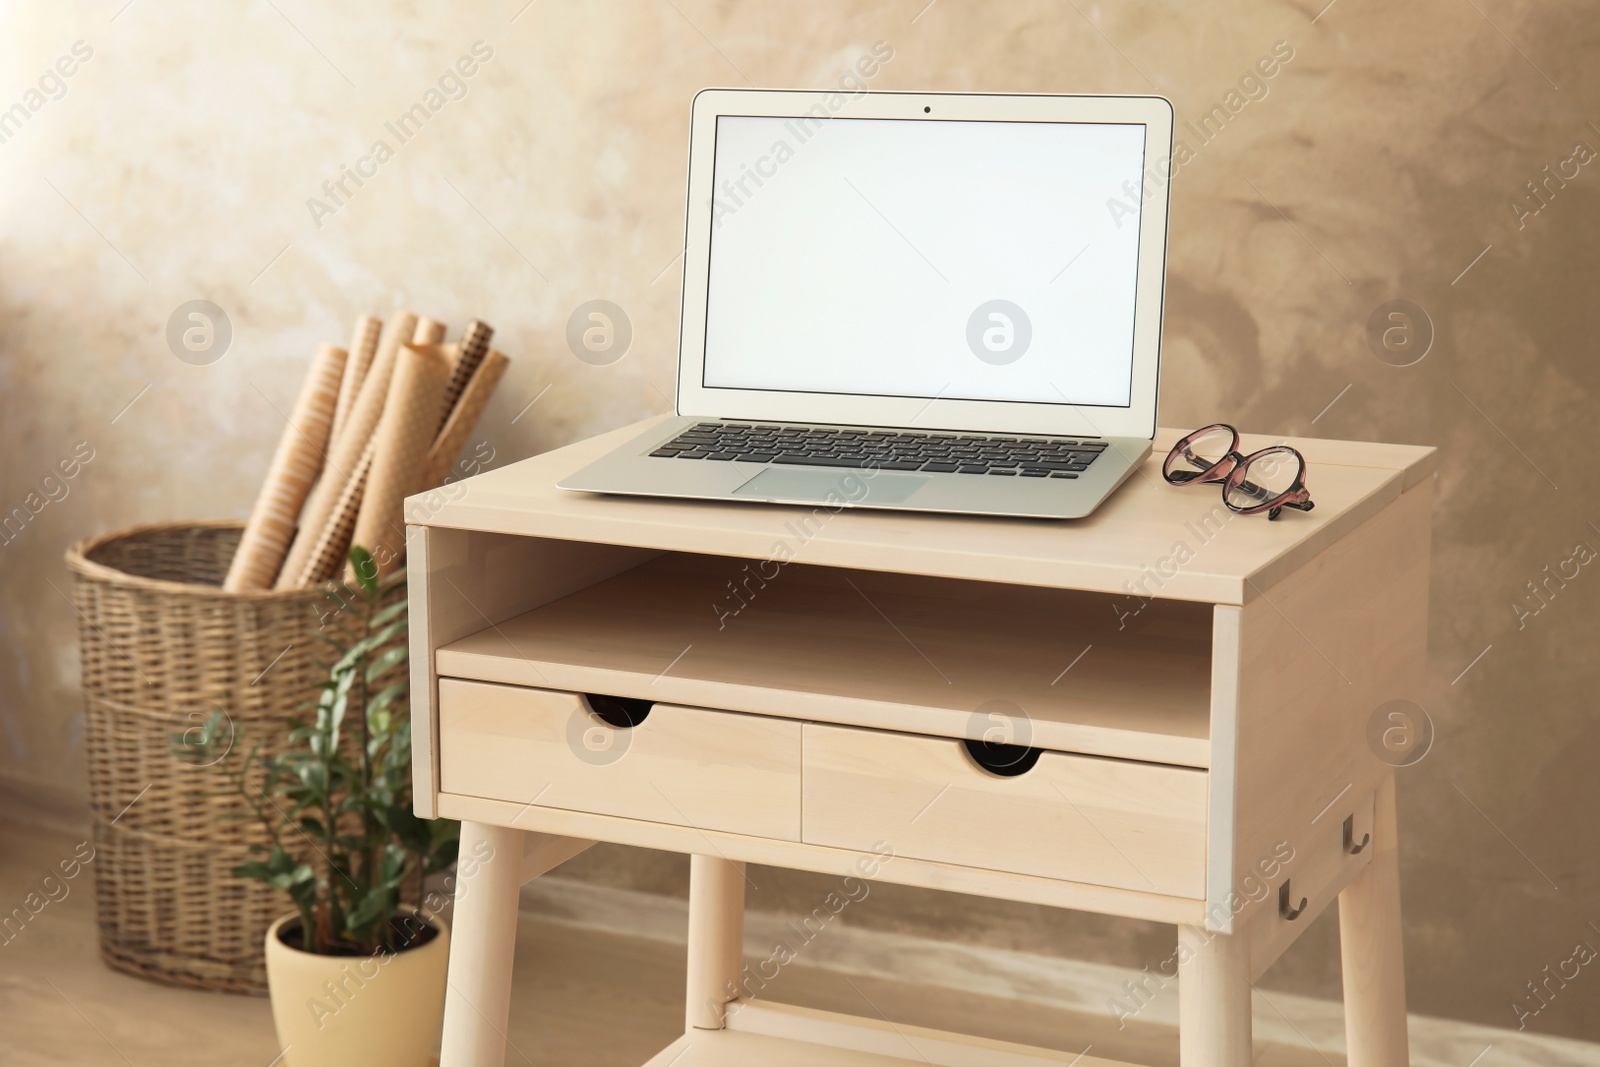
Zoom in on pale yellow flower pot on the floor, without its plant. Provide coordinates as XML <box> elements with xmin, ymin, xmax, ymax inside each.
<box><xmin>267</xmin><ymin>915</ymin><xmax>450</xmax><ymax>1067</ymax></box>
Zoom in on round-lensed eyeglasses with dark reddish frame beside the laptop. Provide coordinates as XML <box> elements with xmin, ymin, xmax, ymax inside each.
<box><xmin>1162</xmin><ymin>422</ymin><xmax>1314</xmax><ymax>518</ymax></box>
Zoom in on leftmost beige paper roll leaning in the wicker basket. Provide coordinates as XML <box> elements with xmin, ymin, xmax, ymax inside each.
<box><xmin>222</xmin><ymin>344</ymin><xmax>347</xmax><ymax>593</ymax></box>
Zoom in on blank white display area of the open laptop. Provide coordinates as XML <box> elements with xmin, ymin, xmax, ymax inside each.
<box><xmin>702</xmin><ymin>115</ymin><xmax>1146</xmax><ymax>408</ymax></box>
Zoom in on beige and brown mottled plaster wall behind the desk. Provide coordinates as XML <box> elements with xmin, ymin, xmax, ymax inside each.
<box><xmin>0</xmin><ymin>0</ymin><xmax>1600</xmax><ymax>1038</ymax></box>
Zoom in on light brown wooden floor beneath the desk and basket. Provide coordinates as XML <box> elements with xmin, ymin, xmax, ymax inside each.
<box><xmin>0</xmin><ymin>821</ymin><xmax>1363</xmax><ymax>1067</ymax></box>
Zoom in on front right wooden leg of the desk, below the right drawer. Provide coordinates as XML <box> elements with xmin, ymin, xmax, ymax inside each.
<box><xmin>1178</xmin><ymin>926</ymin><xmax>1251</xmax><ymax>1067</ymax></box>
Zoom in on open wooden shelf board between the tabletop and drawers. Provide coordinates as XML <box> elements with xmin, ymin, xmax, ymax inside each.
<box><xmin>435</xmin><ymin>553</ymin><xmax>1211</xmax><ymax>766</ymax></box>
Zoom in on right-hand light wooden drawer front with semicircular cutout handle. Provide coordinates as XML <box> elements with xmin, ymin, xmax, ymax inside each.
<box><xmin>803</xmin><ymin>723</ymin><xmax>1206</xmax><ymax>897</ymax></box>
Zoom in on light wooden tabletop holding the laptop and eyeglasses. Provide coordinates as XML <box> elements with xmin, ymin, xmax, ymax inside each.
<box><xmin>406</xmin><ymin>416</ymin><xmax>1435</xmax><ymax>605</ymax></box>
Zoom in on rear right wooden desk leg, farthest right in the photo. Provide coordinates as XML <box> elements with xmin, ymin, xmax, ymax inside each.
<box><xmin>1339</xmin><ymin>774</ymin><xmax>1411</xmax><ymax>1067</ymax></box>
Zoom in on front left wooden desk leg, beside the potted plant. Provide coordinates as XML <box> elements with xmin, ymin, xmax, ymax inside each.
<box><xmin>438</xmin><ymin>822</ymin><xmax>525</xmax><ymax>1067</ymax></box>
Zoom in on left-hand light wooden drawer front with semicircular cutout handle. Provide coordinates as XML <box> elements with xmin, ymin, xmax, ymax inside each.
<box><xmin>438</xmin><ymin>678</ymin><xmax>800</xmax><ymax>841</ymax></box>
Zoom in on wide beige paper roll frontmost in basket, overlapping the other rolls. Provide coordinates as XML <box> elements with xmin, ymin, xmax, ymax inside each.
<box><xmin>349</xmin><ymin>344</ymin><xmax>450</xmax><ymax>581</ymax></box>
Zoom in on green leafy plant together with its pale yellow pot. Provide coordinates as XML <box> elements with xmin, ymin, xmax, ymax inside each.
<box><xmin>174</xmin><ymin>547</ymin><xmax>459</xmax><ymax>1067</ymax></box>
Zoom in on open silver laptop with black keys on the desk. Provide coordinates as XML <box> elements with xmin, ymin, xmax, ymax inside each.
<box><xmin>560</xmin><ymin>90</ymin><xmax>1173</xmax><ymax>518</ymax></box>
